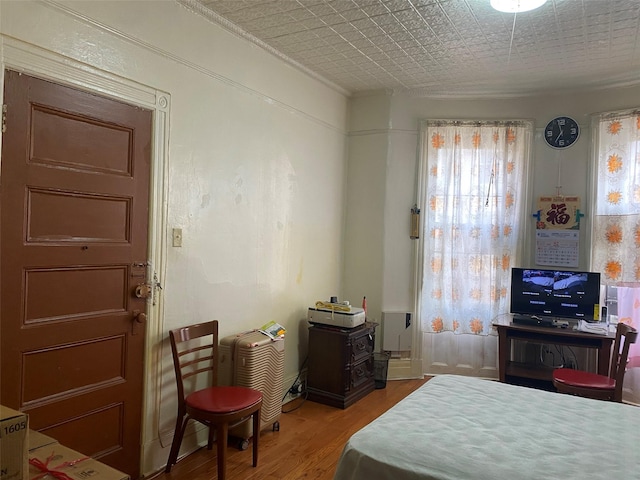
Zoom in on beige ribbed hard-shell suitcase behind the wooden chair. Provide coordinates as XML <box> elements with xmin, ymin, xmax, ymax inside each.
<box><xmin>218</xmin><ymin>330</ymin><xmax>284</xmax><ymax>449</ymax></box>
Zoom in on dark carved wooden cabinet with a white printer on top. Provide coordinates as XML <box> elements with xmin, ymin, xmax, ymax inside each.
<box><xmin>307</xmin><ymin>322</ymin><xmax>378</xmax><ymax>408</ymax></box>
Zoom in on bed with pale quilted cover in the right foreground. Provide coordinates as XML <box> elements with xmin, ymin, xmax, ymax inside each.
<box><xmin>334</xmin><ymin>375</ymin><xmax>640</xmax><ymax>480</ymax></box>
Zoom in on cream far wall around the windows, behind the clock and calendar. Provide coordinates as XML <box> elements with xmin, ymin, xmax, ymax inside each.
<box><xmin>345</xmin><ymin>86</ymin><xmax>640</xmax><ymax>376</ymax></box>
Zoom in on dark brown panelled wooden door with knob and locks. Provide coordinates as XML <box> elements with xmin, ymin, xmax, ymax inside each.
<box><xmin>0</xmin><ymin>71</ymin><xmax>151</xmax><ymax>478</ymax></box>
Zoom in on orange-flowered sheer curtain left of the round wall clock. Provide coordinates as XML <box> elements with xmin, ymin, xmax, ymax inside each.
<box><xmin>420</xmin><ymin>121</ymin><xmax>533</xmax><ymax>335</ymax></box>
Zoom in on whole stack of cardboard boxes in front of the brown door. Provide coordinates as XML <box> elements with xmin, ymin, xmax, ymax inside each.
<box><xmin>0</xmin><ymin>405</ymin><xmax>129</xmax><ymax>480</ymax></box>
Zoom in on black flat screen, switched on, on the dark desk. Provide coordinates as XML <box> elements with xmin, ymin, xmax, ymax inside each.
<box><xmin>511</xmin><ymin>268</ymin><xmax>600</xmax><ymax>322</ymax></box>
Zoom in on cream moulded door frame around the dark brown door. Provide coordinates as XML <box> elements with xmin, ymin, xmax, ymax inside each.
<box><xmin>0</xmin><ymin>35</ymin><xmax>171</xmax><ymax>475</ymax></box>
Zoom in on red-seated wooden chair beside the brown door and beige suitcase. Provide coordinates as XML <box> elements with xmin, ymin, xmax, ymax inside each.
<box><xmin>165</xmin><ymin>320</ymin><xmax>262</xmax><ymax>480</ymax></box>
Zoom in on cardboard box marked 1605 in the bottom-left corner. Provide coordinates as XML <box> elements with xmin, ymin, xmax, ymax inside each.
<box><xmin>0</xmin><ymin>405</ymin><xmax>29</xmax><ymax>480</ymax></box>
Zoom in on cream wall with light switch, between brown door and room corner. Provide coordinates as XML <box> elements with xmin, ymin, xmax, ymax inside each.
<box><xmin>0</xmin><ymin>0</ymin><xmax>347</xmax><ymax>474</ymax></box>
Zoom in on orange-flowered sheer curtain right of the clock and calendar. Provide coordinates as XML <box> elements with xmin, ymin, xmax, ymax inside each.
<box><xmin>591</xmin><ymin>110</ymin><xmax>640</xmax><ymax>403</ymax></box>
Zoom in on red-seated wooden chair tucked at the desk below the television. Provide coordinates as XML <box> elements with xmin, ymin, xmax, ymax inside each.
<box><xmin>553</xmin><ymin>323</ymin><xmax>638</xmax><ymax>402</ymax></box>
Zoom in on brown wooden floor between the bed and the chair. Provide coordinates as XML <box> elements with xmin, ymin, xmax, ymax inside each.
<box><xmin>153</xmin><ymin>378</ymin><xmax>428</xmax><ymax>480</ymax></box>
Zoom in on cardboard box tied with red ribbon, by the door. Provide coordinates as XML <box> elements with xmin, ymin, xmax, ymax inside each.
<box><xmin>28</xmin><ymin>443</ymin><xmax>130</xmax><ymax>480</ymax></box>
